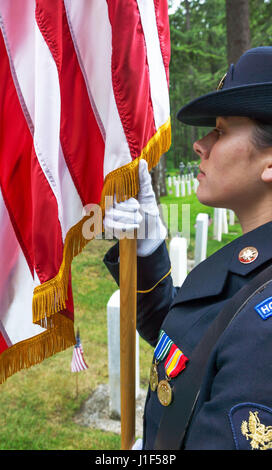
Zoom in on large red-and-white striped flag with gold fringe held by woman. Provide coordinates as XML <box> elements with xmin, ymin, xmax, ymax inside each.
<box><xmin>0</xmin><ymin>0</ymin><xmax>171</xmax><ymax>383</ymax></box>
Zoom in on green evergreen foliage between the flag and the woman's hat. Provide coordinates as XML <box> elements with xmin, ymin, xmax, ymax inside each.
<box><xmin>167</xmin><ymin>0</ymin><xmax>272</xmax><ymax>171</ymax></box>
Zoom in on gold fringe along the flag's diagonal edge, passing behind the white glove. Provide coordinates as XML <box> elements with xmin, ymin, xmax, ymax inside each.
<box><xmin>32</xmin><ymin>118</ymin><xmax>171</xmax><ymax>326</ymax></box>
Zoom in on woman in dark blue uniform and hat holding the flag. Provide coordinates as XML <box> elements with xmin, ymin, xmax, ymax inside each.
<box><xmin>104</xmin><ymin>47</ymin><xmax>272</xmax><ymax>450</ymax></box>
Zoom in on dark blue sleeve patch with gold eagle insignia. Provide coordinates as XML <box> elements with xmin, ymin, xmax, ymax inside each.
<box><xmin>229</xmin><ymin>403</ymin><xmax>272</xmax><ymax>450</ymax></box>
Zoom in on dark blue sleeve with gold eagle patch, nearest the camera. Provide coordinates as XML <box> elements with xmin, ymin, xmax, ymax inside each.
<box><xmin>185</xmin><ymin>288</ymin><xmax>272</xmax><ymax>450</ymax></box>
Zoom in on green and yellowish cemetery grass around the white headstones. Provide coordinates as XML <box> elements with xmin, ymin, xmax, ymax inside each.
<box><xmin>0</xmin><ymin>186</ymin><xmax>241</xmax><ymax>450</ymax></box>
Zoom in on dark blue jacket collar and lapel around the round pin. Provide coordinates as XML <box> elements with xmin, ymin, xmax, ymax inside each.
<box><xmin>171</xmin><ymin>222</ymin><xmax>272</xmax><ymax>307</ymax></box>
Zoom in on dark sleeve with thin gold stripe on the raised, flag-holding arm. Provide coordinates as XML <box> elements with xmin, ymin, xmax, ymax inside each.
<box><xmin>104</xmin><ymin>242</ymin><xmax>177</xmax><ymax>346</ymax></box>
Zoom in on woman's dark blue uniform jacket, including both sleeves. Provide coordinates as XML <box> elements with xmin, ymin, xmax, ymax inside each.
<box><xmin>104</xmin><ymin>222</ymin><xmax>272</xmax><ymax>450</ymax></box>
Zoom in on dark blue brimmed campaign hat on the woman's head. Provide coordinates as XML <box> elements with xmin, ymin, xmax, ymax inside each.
<box><xmin>177</xmin><ymin>46</ymin><xmax>272</xmax><ymax>127</ymax></box>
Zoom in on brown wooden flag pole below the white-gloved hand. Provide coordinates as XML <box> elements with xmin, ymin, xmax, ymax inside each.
<box><xmin>119</xmin><ymin>232</ymin><xmax>137</xmax><ymax>450</ymax></box>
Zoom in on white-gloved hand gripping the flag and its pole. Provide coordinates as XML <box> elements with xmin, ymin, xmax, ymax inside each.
<box><xmin>104</xmin><ymin>160</ymin><xmax>167</xmax><ymax>256</ymax></box>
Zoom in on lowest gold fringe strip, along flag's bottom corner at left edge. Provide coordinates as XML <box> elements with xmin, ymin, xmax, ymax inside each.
<box><xmin>0</xmin><ymin>313</ymin><xmax>75</xmax><ymax>384</ymax></box>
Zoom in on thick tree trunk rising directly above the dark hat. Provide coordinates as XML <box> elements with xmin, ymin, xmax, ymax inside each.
<box><xmin>226</xmin><ymin>0</ymin><xmax>251</xmax><ymax>65</ymax></box>
